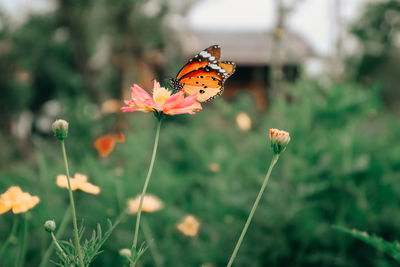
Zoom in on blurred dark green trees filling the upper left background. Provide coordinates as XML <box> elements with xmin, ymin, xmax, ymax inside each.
<box><xmin>0</xmin><ymin>0</ymin><xmax>173</xmax><ymax>130</ymax></box>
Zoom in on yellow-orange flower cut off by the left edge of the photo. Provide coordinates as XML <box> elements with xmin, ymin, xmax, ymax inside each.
<box><xmin>0</xmin><ymin>186</ymin><xmax>40</xmax><ymax>214</ymax></box>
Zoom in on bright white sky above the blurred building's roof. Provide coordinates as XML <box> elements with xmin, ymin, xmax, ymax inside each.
<box><xmin>189</xmin><ymin>0</ymin><xmax>376</xmax><ymax>55</ymax></box>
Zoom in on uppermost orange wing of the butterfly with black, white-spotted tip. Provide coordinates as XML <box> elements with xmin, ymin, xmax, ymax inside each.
<box><xmin>176</xmin><ymin>45</ymin><xmax>221</xmax><ymax>80</ymax></box>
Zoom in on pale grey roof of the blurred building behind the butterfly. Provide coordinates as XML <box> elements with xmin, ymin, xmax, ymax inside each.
<box><xmin>181</xmin><ymin>31</ymin><xmax>315</xmax><ymax>66</ymax></box>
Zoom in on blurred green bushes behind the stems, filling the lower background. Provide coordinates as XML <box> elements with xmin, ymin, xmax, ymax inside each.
<box><xmin>0</xmin><ymin>78</ymin><xmax>400</xmax><ymax>266</ymax></box>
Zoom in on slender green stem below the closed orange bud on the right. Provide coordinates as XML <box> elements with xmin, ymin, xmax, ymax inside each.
<box><xmin>227</xmin><ymin>154</ymin><xmax>279</xmax><ymax>267</ymax></box>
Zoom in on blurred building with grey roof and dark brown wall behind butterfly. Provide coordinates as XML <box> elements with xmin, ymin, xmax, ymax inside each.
<box><xmin>178</xmin><ymin>30</ymin><xmax>315</xmax><ymax>109</ymax></box>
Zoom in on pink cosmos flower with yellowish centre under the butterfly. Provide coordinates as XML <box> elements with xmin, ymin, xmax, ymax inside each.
<box><xmin>121</xmin><ymin>81</ymin><xmax>202</xmax><ymax>115</ymax></box>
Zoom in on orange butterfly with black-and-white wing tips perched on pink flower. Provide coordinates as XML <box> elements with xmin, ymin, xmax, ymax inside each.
<box><xmin>170</xmin><ymin>45</ymin><xmax>236</xmax><ymax>102</ymax></box>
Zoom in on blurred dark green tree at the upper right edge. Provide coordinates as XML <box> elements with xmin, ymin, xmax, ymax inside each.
<box><xmin>350</xmin><ymin>0</ymin><xmax>400</xmax><ymax>110</ymax></box>
